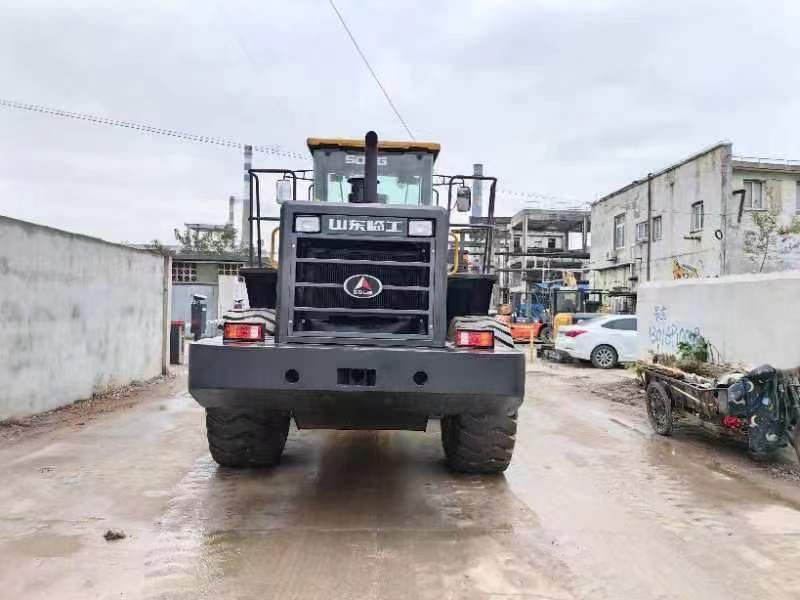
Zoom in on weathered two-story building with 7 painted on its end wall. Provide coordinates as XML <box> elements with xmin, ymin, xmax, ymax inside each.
<box><xmin>590</xmin><ymin>142</ymin><xmax>800</xmax><ymax>289</ymax></box>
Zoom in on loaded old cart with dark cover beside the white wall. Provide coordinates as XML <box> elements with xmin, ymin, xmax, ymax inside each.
<box><xmin>638</xmin><ymin>363</ymin><xmax>800</xmax><ymax>458</ymax></box>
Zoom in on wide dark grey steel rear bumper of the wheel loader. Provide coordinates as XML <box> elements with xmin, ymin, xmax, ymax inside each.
<box><xmin>189</xmin><ymin>338</ymin><xmax>525</xmax><ymax>416</ymax></box>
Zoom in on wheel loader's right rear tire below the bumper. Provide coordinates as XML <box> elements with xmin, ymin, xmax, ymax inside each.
<box><xmin>441</xmin><ymin>412</ymin><xmax>517</xmax><ymax>474</ymax></box>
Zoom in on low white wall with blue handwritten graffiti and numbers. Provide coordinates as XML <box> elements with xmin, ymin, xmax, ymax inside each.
<box><xmin>637</xmin><ymin>271</ymin><xmax>800</xmax><ymax>369</ymax></box>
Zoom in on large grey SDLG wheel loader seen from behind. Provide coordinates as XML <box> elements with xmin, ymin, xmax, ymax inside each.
<box><xmin>189</xmin><ymin>132</ymin><xmax>525</xmax><ymax>473</ymax></box>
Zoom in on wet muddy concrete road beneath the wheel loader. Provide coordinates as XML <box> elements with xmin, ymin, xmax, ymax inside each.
<box><xmin>0</xmin><ymin>363</ymin><xmax>800</xmax><ymax>600</ymax></box>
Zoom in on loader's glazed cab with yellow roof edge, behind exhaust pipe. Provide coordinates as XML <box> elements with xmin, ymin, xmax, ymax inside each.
<box><xmin>308</xmin><ymin>138</ymin><xmax>439</xmax><ymax>206</ymax></box>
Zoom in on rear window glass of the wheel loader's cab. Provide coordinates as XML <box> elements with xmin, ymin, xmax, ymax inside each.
<box><xmin>314</xmin><ymin>149</ymin><xmax>433</xmax><ymax>206</ymax></box>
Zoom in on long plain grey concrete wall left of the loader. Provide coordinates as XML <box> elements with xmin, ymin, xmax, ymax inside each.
<box><xmin>0</xmin><ymin>216</ymin><xmax>170</xmax><ymax>419</ymax></box>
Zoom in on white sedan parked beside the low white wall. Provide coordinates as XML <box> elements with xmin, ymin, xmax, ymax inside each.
<box><xmin>556</xmin><ymin>315</ymin><xmax>637</xmax><ymax>369</ymax></box>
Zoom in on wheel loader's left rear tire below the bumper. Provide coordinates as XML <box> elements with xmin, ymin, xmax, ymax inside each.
<box><xmin>206</xmin><ymin>407</ymin><xmax>289</xmax><ymax>468</ymax></box>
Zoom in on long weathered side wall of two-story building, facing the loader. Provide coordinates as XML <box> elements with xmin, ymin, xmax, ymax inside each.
<box><xmin>591</xmin><ymin>144</ymin><xmax>731</xmax><ymax>289</ymax></box>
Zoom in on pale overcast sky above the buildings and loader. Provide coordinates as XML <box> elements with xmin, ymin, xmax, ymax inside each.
<box><xmin>0</xmin><ymin>0</ymin><xmax>800</xmax><ymax>242</ymax></box>
